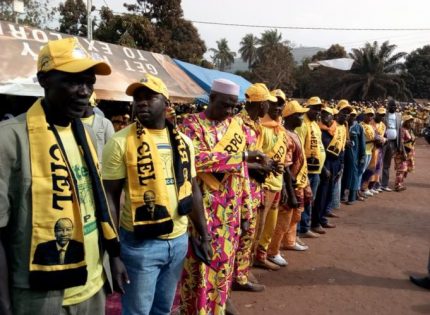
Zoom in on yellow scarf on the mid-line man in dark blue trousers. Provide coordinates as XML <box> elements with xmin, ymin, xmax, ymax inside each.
<box><xmin>303</xmin><ymin>115</ymin><xmax>324</xmax><ymax>171</ymax></box>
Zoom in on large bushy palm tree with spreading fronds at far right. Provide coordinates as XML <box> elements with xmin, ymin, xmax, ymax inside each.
<box><xmin>338</xmin><ymin>41</ymin><xmax>411</xmax><ymax>99</ymax></box>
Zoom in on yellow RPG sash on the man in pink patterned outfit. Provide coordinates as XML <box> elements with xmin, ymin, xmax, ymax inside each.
<box><xmin>197</xmin><ymin>118</ymin><xmax>246</xmax><ymax>190</ymax></box>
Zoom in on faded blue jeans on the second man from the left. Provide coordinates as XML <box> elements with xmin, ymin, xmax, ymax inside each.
<box><xmin>120</xmin><ymin>229</ymin><xmax>188</xmax><ymax>315</ymax></box>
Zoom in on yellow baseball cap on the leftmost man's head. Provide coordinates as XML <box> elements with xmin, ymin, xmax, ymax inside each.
<box><xmin>37</xmin><ymin>37</ymin><xmax>111</xmax><ymax>75</ymax></box>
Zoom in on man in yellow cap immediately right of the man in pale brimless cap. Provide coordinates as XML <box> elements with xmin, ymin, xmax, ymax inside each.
<box><xmin>232</xmin><ymin>83</ymin><xmax>275</xmax><ymax>292</ymax></box>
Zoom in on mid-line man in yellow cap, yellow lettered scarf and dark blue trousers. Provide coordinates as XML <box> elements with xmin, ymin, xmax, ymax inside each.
<box><xmin>296</xmin><ymin>96</ymin><xmax>325</xmax><ymax>238</ymax></box>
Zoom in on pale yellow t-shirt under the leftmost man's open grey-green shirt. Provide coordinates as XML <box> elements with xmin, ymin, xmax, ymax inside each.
<box><xmin>56</xmin><ymin>125</ymin><xmax>105</xmax><ymax>305</ymax></box>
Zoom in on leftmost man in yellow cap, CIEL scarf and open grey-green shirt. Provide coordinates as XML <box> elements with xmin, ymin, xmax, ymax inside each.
<box><xmin>0</xmin><ymin>38</ymin><xmax>125</xmax><ymax>315</ymax></box>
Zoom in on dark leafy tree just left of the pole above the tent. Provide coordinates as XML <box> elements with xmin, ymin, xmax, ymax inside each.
<box><xmin>58</xmin><ymin>0</ymin><xmax>88</xmax><ymax>36</ymax></box>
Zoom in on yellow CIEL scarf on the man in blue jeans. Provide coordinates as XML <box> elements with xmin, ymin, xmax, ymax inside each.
<box><xmin>126</xmin><ymin>122</ymin><xmax>192</xmax><ymax>238</ymax></box>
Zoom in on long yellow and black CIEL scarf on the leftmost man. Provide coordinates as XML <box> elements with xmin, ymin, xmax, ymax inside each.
<box><xmin>27</xmin><ymin>99</ymin><xmax>119</xmax><ymax>290</ymax></box>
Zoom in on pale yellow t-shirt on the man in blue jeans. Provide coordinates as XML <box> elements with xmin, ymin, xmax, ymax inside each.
<box><xmin>102</xmin><ymin>127</ymin><xmax>196</xmax><ymax>239</ymax></box>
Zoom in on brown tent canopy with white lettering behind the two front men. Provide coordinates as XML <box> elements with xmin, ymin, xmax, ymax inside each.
<box><xmin>0</xmin><ymin>21</ymin><xmax>205</xmax><ymax>102</ymax></box>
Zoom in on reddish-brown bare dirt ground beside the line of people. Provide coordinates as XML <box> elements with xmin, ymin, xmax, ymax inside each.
<box><xmin>233</xmin><ymin>142</ymin><xmax>430</xmax><ymax>315</ymax></box>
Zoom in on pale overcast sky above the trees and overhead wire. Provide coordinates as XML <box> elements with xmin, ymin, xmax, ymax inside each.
<box><xmin>93</xmin><ymin>0</ymin><xmax>430</xmax><ymax>52</ymax></box>
